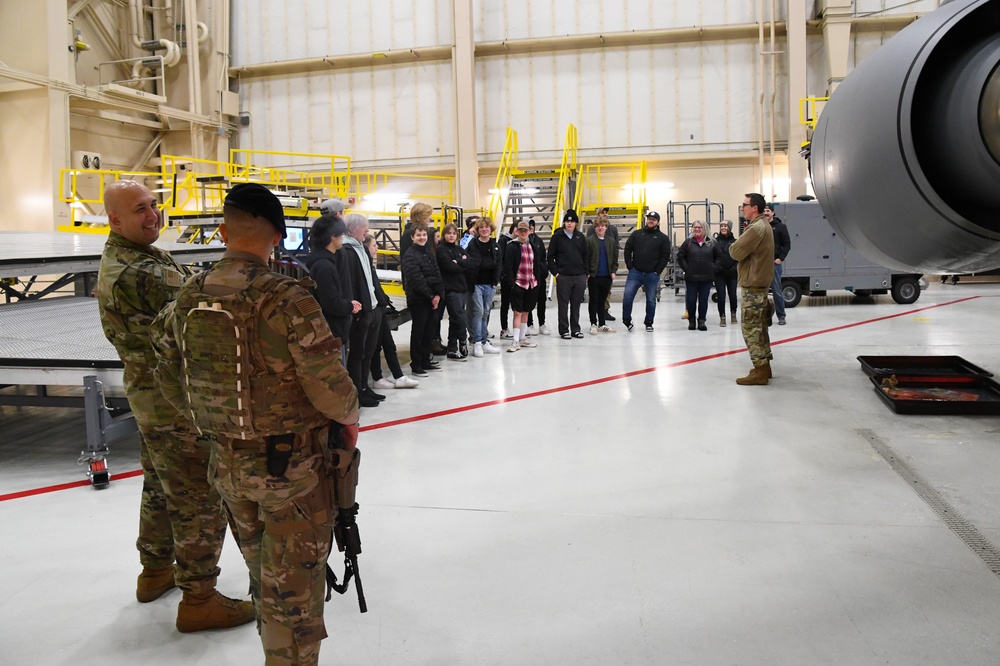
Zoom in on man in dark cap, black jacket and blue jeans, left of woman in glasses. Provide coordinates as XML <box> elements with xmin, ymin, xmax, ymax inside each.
<box><xmin>622</xmin><ymin>210</ymin><xmax>670</xmax><ymax>333</ymax></box>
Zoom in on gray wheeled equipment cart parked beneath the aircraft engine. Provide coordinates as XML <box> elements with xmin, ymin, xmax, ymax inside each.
<box><xmin>774</xmin><ymin>201</ymin><xmax>921</xmax><ymax>308</ymax></box>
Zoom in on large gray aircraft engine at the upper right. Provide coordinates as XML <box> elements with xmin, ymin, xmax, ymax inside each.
<box><xmin>810</xmin><ymin>0</ymin><xmax>1000</xmax><ymax>273</ymax></box>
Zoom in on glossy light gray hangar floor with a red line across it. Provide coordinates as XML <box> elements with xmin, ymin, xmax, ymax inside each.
<box><xmin>0</xmin><ymin>280</ymin><xmax>1000</xmax><ymax>666</ymax></box>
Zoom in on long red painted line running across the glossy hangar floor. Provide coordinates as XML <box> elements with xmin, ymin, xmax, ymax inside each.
<box><xmin>0</xmin><ymin>296</ymin><xmax>982</xmax><ymax>502</ymax></box>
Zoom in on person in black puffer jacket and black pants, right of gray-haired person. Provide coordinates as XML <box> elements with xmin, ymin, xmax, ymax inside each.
<box><xmin>403</xmin><ymin>223</ymin><xmax>444</xmax><ymax>370</ymax></box>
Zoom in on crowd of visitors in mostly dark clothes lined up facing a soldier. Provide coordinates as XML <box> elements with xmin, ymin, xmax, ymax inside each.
<box><xmin>306</xmin><ymin>192</ymin><xmax>787</xmax><ymax>396</ymax></box>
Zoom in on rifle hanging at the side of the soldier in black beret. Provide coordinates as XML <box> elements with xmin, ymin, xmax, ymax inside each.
<box><xmin>326</xmin><ymin>422</ymin><xmax>368</xmax><ymax>613</ymax></box>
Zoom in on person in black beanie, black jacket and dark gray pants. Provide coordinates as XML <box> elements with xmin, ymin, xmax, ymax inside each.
<box><xmin>549</xmin><ymin>208</ymin><xmax>588</xmax><ymax>340</ymax></box>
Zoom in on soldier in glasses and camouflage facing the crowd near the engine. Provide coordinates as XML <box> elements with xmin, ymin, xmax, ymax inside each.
<box><xmin>729</xmin><ymin>192</ymin><xmax>774</xmax><ymax>386</ymax></box>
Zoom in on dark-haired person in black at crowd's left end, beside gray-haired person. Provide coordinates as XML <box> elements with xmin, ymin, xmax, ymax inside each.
<box><xmin>303</xmin><ymin>215</ymin><xmax>361</xmax><ymax>352</ymax></box>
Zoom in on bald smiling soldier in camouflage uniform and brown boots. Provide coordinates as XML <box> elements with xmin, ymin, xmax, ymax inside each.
<box><xmin>97</xmin><ymin>181</ymin><xmax>254</xmax><ymax>632</ymax></box>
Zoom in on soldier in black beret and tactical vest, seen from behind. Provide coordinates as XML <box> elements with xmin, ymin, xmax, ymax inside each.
<box><xmin>150</xmin><ymin>184</ymin><xmax>358</xmax><ymax>666</ymax></box>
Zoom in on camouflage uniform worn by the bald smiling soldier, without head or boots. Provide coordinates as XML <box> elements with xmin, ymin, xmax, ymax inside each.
<box><xmin>97</xmin><ymin>232</ymin><xmax>227</xmax><ymax>594</ymax></box>
